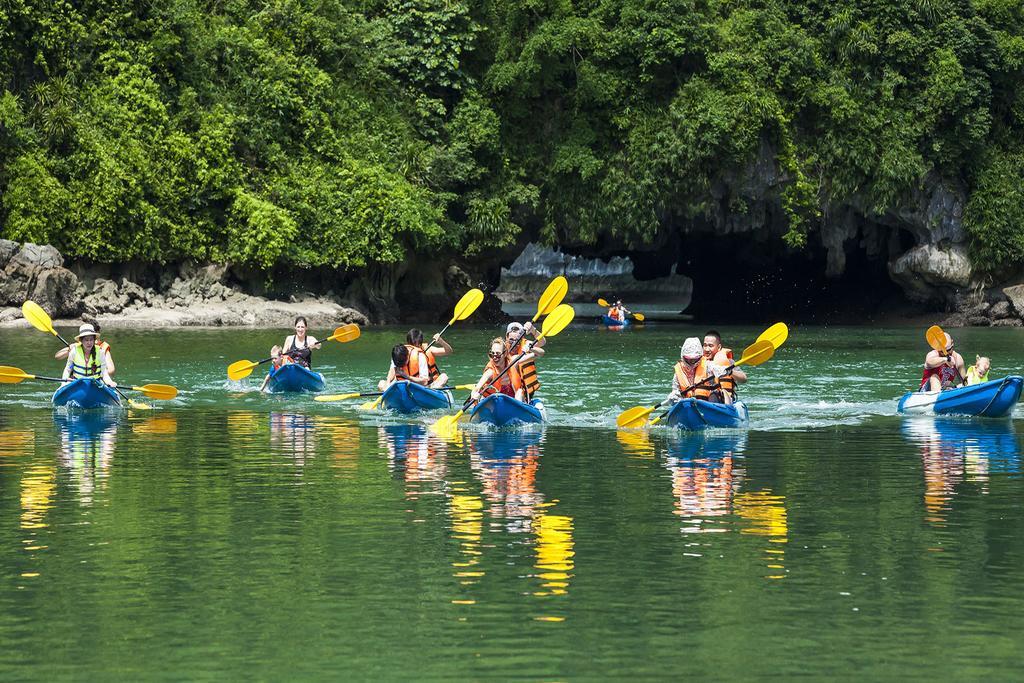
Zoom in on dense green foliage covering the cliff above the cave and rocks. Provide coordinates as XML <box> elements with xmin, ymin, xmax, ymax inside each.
<box><xmin>0</xmin><ymin>0</ymin><xmax>1024</xmax><ymax>268</ymax></box>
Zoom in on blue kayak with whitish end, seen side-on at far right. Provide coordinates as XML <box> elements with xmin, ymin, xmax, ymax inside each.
<box><xmin>896</xmin><ymin>375</ymin><xmax>1024</xmax><ymax>418</ymax></box>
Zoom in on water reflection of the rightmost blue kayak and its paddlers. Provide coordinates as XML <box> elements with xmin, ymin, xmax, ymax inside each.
<box><xmin>901</xmin><ymin>416</ymin><xmax>1020</xmax><ymax>524</ymax></box>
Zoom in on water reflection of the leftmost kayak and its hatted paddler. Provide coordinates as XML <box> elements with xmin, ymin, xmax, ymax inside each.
<box><xmin>53</xmin><ymin>411</ymin><xmax>122</xmax><ymax>505</ymax></box>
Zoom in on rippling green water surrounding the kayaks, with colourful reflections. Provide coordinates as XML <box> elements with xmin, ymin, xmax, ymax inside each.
<box><xmin>0</xmin><ymin>325</ymin><xmax>1024</xmax><ymax>680</ymax></box>
